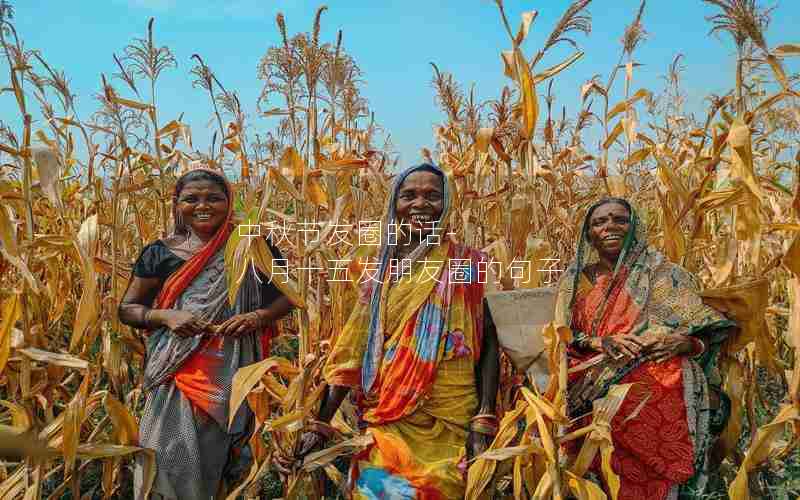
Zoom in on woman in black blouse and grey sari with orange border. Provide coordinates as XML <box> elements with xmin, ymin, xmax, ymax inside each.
<box><xmin>119</xmin><ymin>169</ymin><xmax>290</xmax><ymax>499</ymax></box>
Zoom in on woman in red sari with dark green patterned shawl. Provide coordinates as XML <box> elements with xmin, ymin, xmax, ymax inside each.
<box><xmin>556</xmin><ymin>198</ymin><xmax>734</xmax><ymax>500</ymax></box>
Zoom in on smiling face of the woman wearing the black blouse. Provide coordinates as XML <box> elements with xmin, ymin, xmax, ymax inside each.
<box><xmin>178</xmin><ymin>180</ymin><xmax>228</xmax><ymax>238</ymax></box>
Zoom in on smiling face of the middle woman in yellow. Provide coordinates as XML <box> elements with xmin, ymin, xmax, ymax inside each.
<box><xmin>395</xmin><ymin>171</ymin><xmax>444</xmax><ymax>241</ymax></box>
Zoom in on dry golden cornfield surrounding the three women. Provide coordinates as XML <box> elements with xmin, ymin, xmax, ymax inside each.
<box><xmin>0</xmin><ymin>0</ymin><xmax>800</xmax><ymax>499</ymax></box>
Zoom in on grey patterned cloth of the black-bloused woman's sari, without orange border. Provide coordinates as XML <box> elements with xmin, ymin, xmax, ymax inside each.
<box><xmin>134</xmin><ymin>250</ymin><xmax>265</xmax><ymax>499</ymax></box>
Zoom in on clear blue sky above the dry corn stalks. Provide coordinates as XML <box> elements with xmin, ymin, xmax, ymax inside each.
<box><xmin>0</xmin><ymin>0</ymin><xmax>800</xmax><ymax>164</ymax></box>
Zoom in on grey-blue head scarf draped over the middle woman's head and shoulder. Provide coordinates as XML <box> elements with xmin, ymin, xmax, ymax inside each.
<box><xmin>362</xmin><ymin>163</ymin><xmax>456</xmax><ymax>393</ymax></box>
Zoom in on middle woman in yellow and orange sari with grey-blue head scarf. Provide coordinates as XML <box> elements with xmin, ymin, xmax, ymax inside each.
<box><xmin>298</xmin><ymin>164</ymin><xmax>499</xmax><ymax>499</ymax></box>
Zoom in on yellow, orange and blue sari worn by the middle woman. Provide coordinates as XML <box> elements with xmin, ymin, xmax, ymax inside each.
<box><xmin>324</xmin><ymin>163</ymin><xmax>486</xmax><ymax>500</ymax></box>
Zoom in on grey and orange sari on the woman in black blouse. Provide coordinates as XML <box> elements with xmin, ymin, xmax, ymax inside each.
<box><xmin>134</xmin><ymin>170</ymin><xmax>282</xmax><ymax>499</ymax></box>
